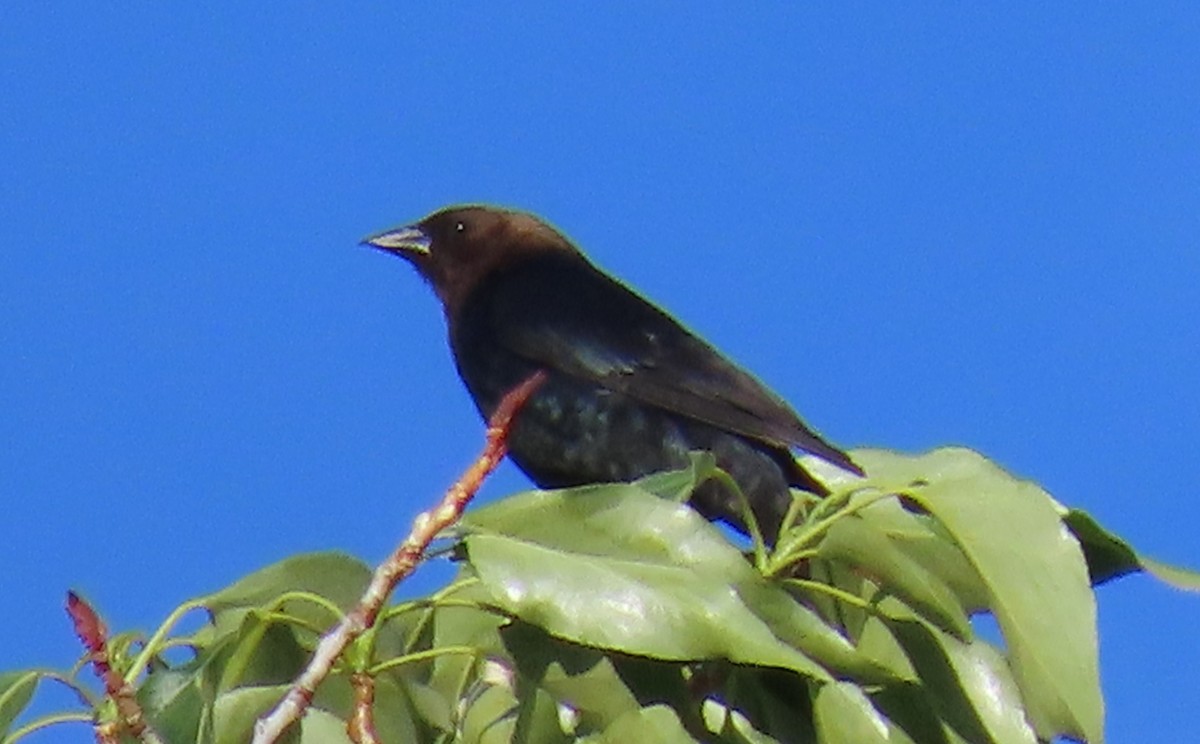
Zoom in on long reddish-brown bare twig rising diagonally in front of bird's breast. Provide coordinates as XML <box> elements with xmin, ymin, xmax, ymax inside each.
<box><xmin>260</xmin><ymin>371</ymin><xmax>546</xmax><ymax>744</ymax></box>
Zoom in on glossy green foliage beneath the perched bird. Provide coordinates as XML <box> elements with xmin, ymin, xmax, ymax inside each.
<box><xmin>0</xmin><ymin>449</ymin><xmax>1200</xmax><ymax>744</ymax></box>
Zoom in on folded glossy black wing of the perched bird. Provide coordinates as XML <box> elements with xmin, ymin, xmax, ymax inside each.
<box><xmin>477</xmin><ymin>258</ymin><xmax>862</xmax><ymax>473</ymax></box>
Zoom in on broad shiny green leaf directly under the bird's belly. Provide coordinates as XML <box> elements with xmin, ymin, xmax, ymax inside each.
<box><xmin>463</xmin><ymin>484</ymin><xmax>912</xmax><ymax>680</ymax></box>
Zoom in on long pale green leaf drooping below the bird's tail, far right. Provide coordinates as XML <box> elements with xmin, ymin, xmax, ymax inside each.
<box><xmin>857</xmin><ymin>448</ymin><xmax>1104</xmax><ymax>742</ymax></box>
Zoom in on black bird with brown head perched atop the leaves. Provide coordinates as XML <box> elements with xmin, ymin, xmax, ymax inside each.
<box><xmin>362</xmin><ymin>204</ymin><xmax>863</xmax><ymax>544</ymax></box>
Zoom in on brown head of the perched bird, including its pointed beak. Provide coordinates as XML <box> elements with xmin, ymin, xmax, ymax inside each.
<box><xmin>362</xmin><ymin>205</ymin><xmax>578</xmax><ymax>317</ymax></box>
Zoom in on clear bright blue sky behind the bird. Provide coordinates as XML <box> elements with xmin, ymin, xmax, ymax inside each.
<box><xmin>0</xmin><ymin>2</ymin><xmax>1200</xmax><ymax>742</ymax></box>
